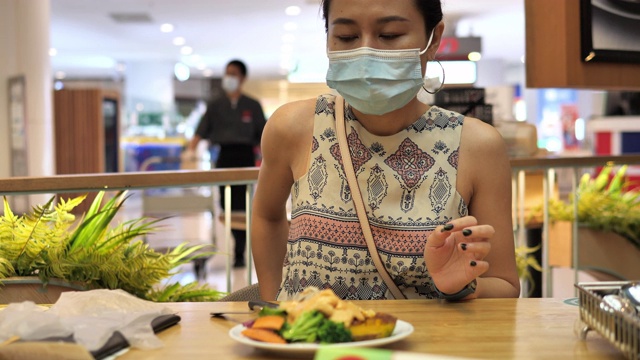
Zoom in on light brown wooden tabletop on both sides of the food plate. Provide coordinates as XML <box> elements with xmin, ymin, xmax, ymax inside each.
<box><xmin>119</xmin><ymin>298</ymin><xmax>623</xmax><ymax>360</ymax></box>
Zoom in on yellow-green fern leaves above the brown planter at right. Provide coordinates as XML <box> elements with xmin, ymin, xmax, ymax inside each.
<box><xmin>549</xmin><ymin>165</ymin><xmax>640</xmax><ymax>248</ymax></box>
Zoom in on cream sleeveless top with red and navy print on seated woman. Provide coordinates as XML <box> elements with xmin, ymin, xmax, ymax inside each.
<box><xmin>277</xmin><ymin>95</ymin><xmax>467</xmax><ymax>301</ymax></box>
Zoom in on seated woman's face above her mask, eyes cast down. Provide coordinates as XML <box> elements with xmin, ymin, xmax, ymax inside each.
<box><xmin>327</xmin><ymin>0</ymin><xmax>428</xmax><ymax>51</ymax></box>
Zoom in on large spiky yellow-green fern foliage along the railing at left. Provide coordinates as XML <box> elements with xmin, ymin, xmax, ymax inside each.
<box><xmin>0</xmin><ymin>192</ymin><xmax>224</xmax><ymax>302</ymax></box>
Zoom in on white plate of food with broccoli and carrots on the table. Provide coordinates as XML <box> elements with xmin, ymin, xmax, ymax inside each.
<box><xmin>229</xmin><ymin>289</ymin><xmax>414</xmax><ymax>355</ymax></box>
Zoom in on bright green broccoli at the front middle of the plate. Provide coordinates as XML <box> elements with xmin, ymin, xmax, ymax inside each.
<box><xmin>280</xmin><ymin>310</ymin><xmax>351</xmax><ymax>344</ymax></box>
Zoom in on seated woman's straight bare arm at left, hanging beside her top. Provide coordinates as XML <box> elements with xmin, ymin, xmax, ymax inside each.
<box><xmin>251</xmin><ymin>102</ymin><xmax>313</xmax><ymax>300</ymax></box>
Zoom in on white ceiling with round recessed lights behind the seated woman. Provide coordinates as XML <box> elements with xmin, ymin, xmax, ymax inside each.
<box><xmin>51</xmin><ymin>0</ymin><xmax>524</xmax><ymax>79</ymax></box>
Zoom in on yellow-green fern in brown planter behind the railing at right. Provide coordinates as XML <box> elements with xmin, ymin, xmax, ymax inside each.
<box><xmin>536</xmin><ymin>165</ymin><xmax>640</xmax><ymax>280</ymax></box>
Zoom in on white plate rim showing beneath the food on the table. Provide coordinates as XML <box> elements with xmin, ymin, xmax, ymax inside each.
<box><xmin>229</xmin><ymin>320</ymin><xmax>413</xmax><ymax>355</ymax></box>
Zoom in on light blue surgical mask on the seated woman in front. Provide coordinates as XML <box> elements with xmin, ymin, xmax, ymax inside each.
<box><xmin>327</xmin><ymin>34</ymin><xmax>433</xmax><ymax>115</ymax></box>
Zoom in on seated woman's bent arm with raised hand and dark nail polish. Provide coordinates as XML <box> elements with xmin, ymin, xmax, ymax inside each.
<box><xmin>425</xmin><ymin>118</ymin><xmax>520</xmax><ymax>298</ymax></box>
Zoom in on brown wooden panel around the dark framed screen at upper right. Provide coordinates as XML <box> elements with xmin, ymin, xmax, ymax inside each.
<box><xmin>525</xmin><ymin>0</ymin><xmax>640</xmax><ymax>90</ymax></box>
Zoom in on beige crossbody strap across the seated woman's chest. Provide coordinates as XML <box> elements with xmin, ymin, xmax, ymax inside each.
<box><xmin>335</xmin><ymin>96</ymin><xmax>407</xmax><ymax>299</ymax></box>
